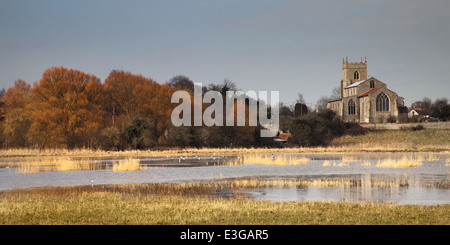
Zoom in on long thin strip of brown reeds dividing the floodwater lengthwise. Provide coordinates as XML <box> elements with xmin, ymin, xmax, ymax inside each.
<box><xmin>0</xmin><ymin>178</ymin><xmax>450</xmax><ymax>201</ymax></box>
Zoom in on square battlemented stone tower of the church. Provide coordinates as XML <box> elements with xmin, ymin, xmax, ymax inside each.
<box><xmin>341</xmin><ymin>57</ymin><xmax>367</xmax><ymax>98</ymax></box>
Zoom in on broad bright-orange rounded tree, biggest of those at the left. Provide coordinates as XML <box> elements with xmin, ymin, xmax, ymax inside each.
<box><xmin>29</xmin><ymin>67</ymin><xmax>103</xmax><ymax>148</ymax></box>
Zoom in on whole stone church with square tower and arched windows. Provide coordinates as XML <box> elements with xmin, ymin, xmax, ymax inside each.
<box><xmin>327</xmin><ymin>58</ymin><xmax>408</xmax><ymax>123</ymax></box>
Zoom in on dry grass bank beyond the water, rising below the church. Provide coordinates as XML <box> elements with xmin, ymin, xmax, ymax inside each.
<box><xmin>0</xmin><ymin>129</ymin><xmax>450</xmax><ymax>160</ymax></box>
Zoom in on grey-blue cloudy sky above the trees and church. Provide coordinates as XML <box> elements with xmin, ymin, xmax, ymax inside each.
<box><xmin>0</xmin><ymin>0</ymin><xmax>450</xmax><ymax>107</ymax></box>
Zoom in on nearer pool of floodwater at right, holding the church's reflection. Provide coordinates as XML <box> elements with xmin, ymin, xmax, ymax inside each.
<box><xmin>239</xmin><ymin>174</ymin><xmax>450</xmax><ymax>205</ymax></box>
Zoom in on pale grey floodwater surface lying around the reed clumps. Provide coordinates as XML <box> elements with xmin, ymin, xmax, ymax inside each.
<box><xmin>0</xmin><ymin>153</ymin><xmax>450</xmax><ymax>205</ymax></box>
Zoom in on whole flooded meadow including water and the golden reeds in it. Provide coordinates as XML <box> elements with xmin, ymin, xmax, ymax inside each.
<box><xmin>0</xmin><ymin>153</ymin><xmax>450</xmax><ymax>205</ymax></box>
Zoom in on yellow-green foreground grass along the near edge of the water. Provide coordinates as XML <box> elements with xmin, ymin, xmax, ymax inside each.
<box><xmin>0</xmin><ymin>192</ymin><xmax>450</xmax><ymax>225</ymax></box>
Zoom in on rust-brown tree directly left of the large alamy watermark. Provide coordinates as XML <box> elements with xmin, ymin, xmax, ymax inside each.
<box><xmin>105</xmin><ymin>70</ymin><xmax>173</xmax><ymax>148</ymax></box>
